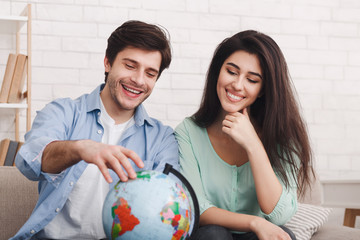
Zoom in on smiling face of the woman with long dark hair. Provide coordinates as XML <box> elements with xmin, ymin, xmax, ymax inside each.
<box><xmin>216</xmin><ymin>50</ymin><xmax>263</xmax><ymax>113</ymax></box>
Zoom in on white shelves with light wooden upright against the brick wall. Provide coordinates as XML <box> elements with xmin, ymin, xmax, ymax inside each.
<box><xmin>0</xmin><ymin>4</ymin><xmax>31</xmax><ymax>141</ymax></box>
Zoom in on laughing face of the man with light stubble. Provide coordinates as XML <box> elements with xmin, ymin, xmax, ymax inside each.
<box><xmin>103</xmin><ymin>47</ymin><xmax>161</xmax><ymax>112</ymax></box>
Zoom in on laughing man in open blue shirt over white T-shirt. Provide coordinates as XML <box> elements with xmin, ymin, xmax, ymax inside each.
<box><xmin>13</xmin><ymin>21</ymin><xmax>178</xmax><ymax>239</ymax></box>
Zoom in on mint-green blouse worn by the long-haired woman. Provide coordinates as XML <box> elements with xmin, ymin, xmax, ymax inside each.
<box><xmin>175</xmin><ymin>118</ymin><xmax>297</xmax><ymax>225</ymax></box>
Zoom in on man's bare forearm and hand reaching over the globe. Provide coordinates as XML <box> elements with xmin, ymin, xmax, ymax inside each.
<box><xmin>41</xmin><ymin>140</ymin><xmax>144</xmax><ymax>183</ymax></box>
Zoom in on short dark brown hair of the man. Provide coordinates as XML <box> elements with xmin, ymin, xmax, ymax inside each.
<box><xmin>105</xmin><ymin>20</ymin><xmax>171</xmax><ymax>82</ymax></box>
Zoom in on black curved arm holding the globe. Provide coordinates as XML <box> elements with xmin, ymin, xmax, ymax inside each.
<box><xmin>163</xmin><ymin>163</ymin><xmax>200</xmax><ymax>239</ymax></box>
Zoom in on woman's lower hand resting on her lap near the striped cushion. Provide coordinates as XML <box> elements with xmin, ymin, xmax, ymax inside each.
<box><xmin>250</xmin><ymin>217</ymin><xmax>291</xmax><ymax>240</ymax></box>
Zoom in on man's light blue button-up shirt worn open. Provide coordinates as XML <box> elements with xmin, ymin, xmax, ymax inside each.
<box><xmin>12</xmin><ymin>84</ymin><xmax>179</xmax><ymax>239</ymax></box>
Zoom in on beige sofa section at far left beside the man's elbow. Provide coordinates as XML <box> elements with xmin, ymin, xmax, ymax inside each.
<box><xmin>0</xmin><ymin>166</ymin><xmax>38</xmax><ymax>239</ymax></box>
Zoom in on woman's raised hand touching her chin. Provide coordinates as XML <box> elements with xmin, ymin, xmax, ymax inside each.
<box><xmin>222</xmin><ymin>108</ymin><xmax>260</xmax><ymax>150</ymax></box>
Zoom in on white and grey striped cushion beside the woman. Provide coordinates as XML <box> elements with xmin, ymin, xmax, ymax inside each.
<box><xmin>285</xmin><ymin>203</ymin><xmax>331</xmax><ymax>240</ymax></box>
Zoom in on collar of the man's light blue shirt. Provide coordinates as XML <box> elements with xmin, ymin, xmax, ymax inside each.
<box><xmin>86</xmin><ymin>83</ymin><xmax>155</xmax><ymax>126</ymax></box>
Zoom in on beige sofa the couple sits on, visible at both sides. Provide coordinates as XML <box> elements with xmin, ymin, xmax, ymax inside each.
<box><xmin>0</xmin><ymin>166</ymin><xmax>360</xmax><ymax>240</ymax></box>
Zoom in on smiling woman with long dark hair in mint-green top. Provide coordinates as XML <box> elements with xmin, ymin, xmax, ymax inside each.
<box><xmin>176</xmin><ymin>30</ymin><xmax>313</xmax><ymax>240</ymax></box>
